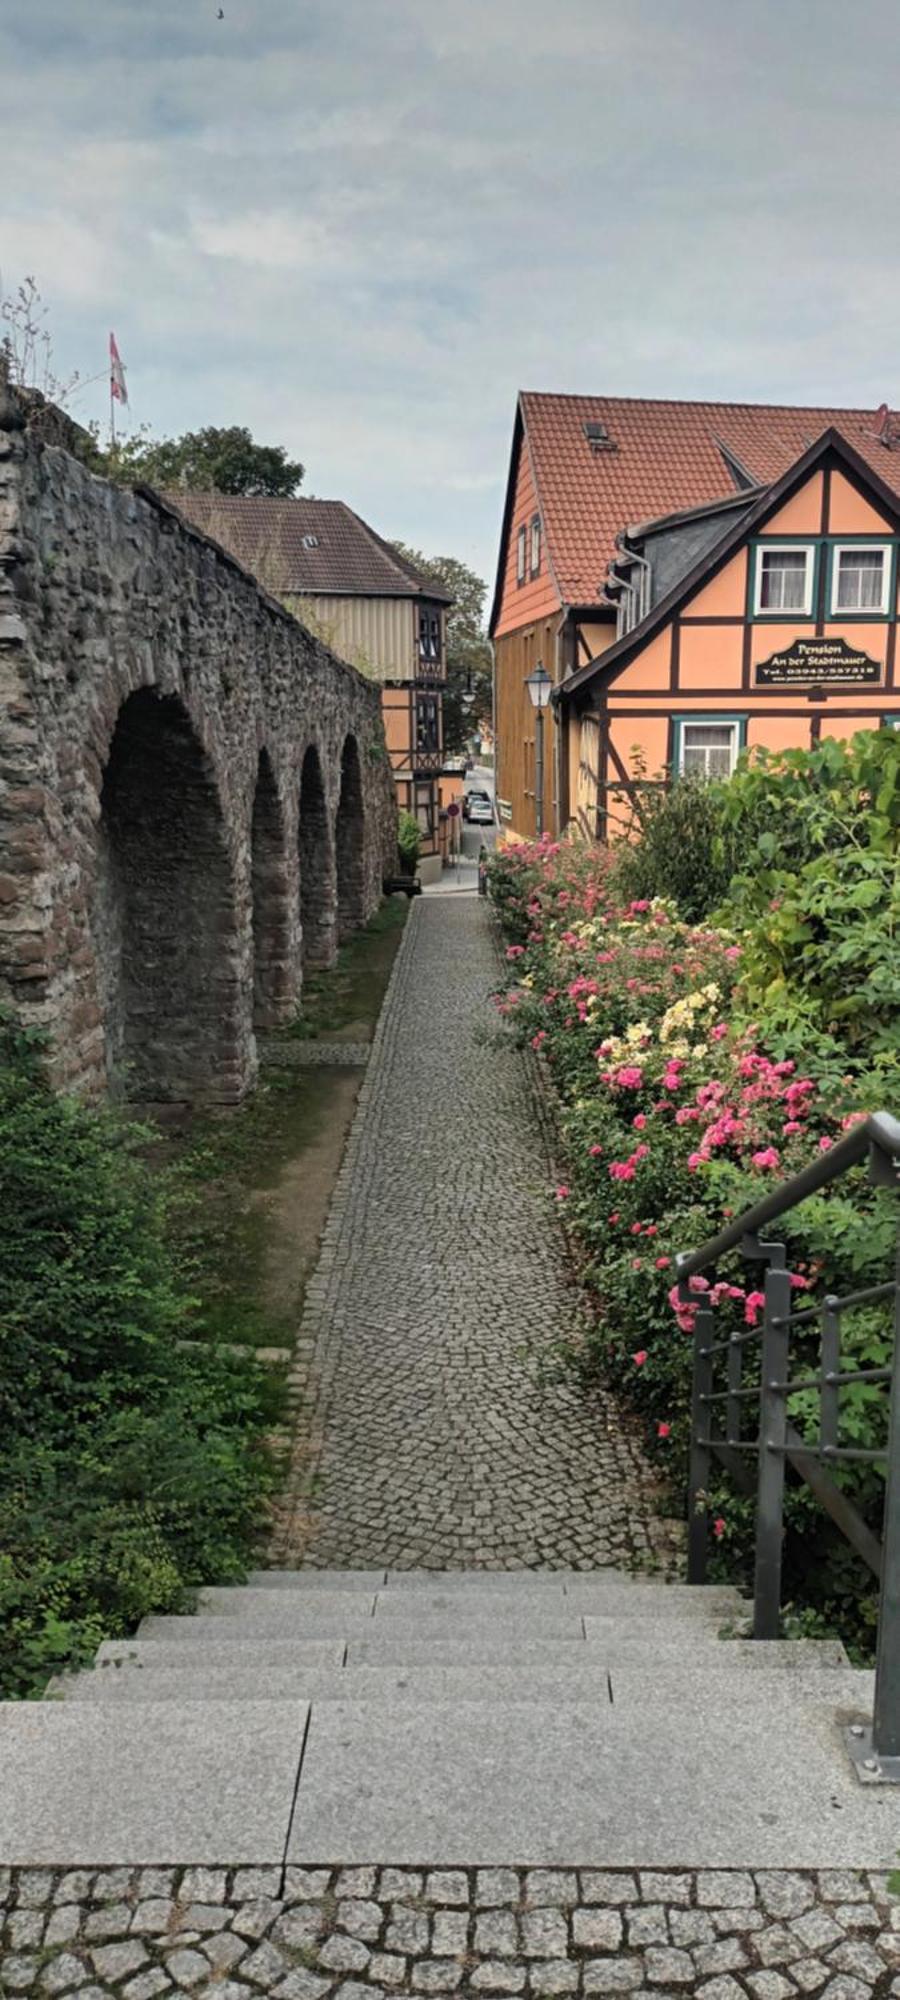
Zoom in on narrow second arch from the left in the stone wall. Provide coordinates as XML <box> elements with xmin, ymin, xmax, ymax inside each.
<box><xmin>250</xmin><ymin>750</ymin><xmax>294</xmax><ymax>1028</ymax></box>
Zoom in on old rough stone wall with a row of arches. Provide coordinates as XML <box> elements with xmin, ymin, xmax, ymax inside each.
<box><xmin>0</xmin><ymin>384</ymin><xmax>396</xmax><ymax>1104</ymax></box>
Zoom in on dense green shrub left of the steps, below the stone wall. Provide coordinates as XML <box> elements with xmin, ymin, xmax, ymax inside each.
<box><xmin>0</xmin><ymin>1018</ymin><xmax>274</xmax><ymax>1696</ymax></box>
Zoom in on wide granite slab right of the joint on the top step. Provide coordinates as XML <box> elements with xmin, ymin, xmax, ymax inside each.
<box><xmin>284</xmin><ymin>1686</ymin><xmax>896</xmax><ymax>1870</ymax></box>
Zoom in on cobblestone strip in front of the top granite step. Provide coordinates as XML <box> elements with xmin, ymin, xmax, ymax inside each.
<box><xmin>0</xmin><ymin>1868</ymin><xmax>900</xmax><ymax>2000</ymax></box>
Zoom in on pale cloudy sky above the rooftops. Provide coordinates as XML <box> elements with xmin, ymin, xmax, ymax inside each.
<box><xmin>0</xmin><ymin>0</ymin><xmax>900</xmax><ymax>578</ymax></box>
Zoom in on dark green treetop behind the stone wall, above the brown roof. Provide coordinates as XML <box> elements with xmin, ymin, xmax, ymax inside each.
<box><xmin>108</xmin><ymin>424</ymin><xmax>304</xmax><ymax>500</ymax></box>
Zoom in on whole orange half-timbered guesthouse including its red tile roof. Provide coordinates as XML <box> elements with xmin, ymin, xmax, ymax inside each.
<box><xmin>490</xmin><ymin>394</ymin><xmax>900</xmax><ymax>838</ymax></box>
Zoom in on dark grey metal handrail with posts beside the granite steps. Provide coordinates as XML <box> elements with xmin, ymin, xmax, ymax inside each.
<box><xmin>676</xmin><ymin>1112</ymin><xmax>900</xmax><ymax>1782</ymax></box>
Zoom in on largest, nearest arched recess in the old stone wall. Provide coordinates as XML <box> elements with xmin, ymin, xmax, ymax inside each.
<box><xmin>92</xmin><ymin>688</ymin><xmax>250</xmax><ymax>1104</ymax></box>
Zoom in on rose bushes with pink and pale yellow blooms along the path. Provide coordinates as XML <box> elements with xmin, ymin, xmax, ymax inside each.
<box><xmin>490</xmin><ymin>820</ymin><xmax>896</xmax><ymax>1636</ymax></box>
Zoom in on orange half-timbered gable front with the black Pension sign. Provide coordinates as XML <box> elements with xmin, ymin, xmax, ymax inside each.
<box><xmin>558</xmin><ymin>434</ymin><xmax>900</xmax><ymax>838</ymax></box>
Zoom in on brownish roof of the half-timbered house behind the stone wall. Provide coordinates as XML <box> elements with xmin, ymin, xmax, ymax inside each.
<box><xmin>164</xmin><ymin>492</ymin><xmax>452</xmax><ymax>604</ymax></box>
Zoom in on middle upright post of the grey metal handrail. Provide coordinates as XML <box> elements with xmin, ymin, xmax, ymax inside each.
<box><xmin>754</xmin><ymin>1244</ymin><xmax>790</xmax><ymax>1638</ymax></box>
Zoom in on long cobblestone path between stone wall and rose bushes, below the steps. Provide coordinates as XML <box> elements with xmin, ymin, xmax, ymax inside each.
<box><xmin>272</xmin><ymin>896</ymin><xmax>672</xmax><ymax>1568</ymax></box>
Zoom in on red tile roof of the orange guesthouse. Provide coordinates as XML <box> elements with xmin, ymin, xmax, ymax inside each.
<box><xmin>520</xmin><ymin>392</ymin><xmax>900</xmax><ymax>604</ymax></box>
